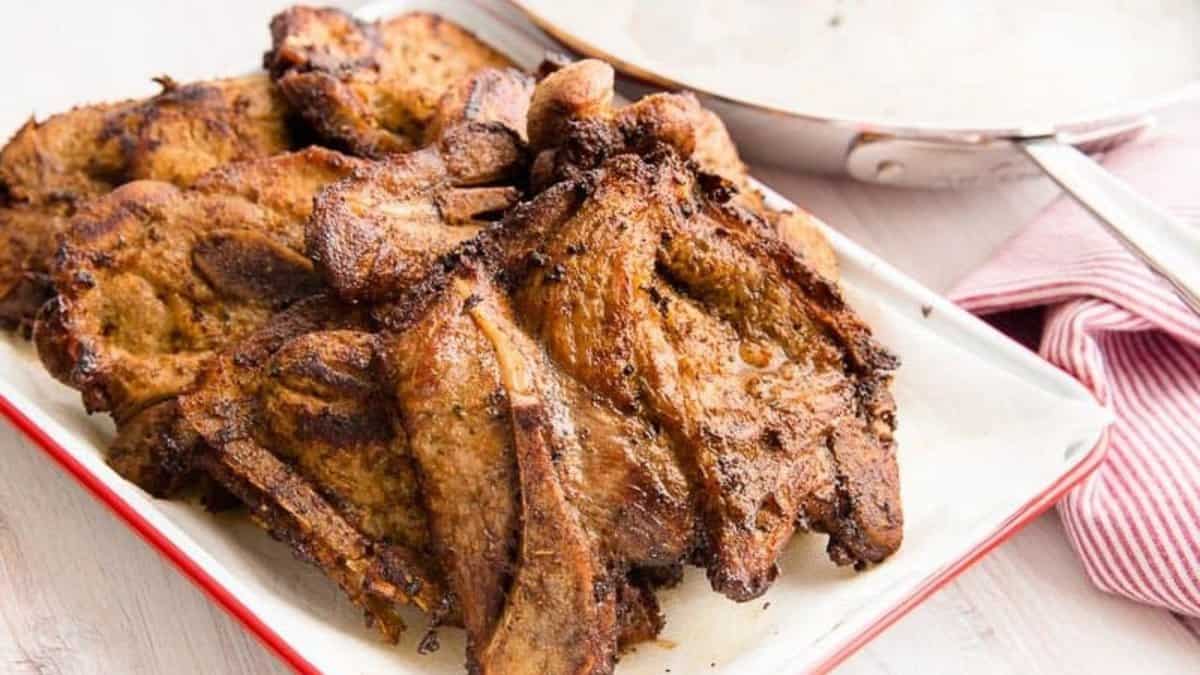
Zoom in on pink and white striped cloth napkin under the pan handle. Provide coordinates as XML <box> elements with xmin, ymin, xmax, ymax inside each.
<box><xmin>950</xmin><ymin>115</ymin><xmax>1200</xmax><ymax>617</ymax></box>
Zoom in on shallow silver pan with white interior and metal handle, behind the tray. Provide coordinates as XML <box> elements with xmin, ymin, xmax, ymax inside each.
<box><xmin>514</xmin><ymin>0</ymin><xmax>1200</xmax><ymax>312</ymax></box>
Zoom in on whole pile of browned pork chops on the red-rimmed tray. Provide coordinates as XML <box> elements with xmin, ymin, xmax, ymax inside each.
<box><xmin>0</xmin><ymin>7</ymin><xmax>902</xmax><ymax>675</ymax></box>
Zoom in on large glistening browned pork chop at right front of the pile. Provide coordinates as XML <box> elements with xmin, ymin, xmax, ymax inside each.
<box><xmin>498</xmin><ymin>150</ymin><xmax>901</xmax><ymax>599</ymax></box>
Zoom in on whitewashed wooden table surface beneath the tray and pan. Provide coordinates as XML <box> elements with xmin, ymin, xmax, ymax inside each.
<box><xmin>0</xmin><ymin>0</ymin><xmax>1200</xmax><ymax>675</ymax></box>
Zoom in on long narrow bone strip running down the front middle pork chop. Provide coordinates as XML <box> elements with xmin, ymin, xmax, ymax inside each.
<box><xmin>467</xmin><ymin>276</ymin><xmax>618</xmax><ymax>675</ymax></box>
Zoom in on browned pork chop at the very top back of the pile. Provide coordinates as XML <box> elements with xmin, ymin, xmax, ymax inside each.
<box><xmin>264</xmin><ymin>6</ymin><xmax>512</xmax><ymax>157</ymax></box>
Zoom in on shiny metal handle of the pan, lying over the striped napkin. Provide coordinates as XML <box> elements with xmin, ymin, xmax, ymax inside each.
<box><xmin>1019</xmin><ymin>137</ymin><xmax>1200</xmax><ymax>313</ymax></box>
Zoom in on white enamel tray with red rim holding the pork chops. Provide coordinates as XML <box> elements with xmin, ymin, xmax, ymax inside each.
<box><xmin>0</xmin><ymin>0</ymin><xmax>1109</xmax><ymax>675</ymax></box>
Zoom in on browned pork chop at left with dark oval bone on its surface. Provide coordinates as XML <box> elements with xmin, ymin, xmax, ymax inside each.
<box><xmin>35</xmin><ymin>148</ymin><xmax>360</xmax><ymax>495</ymax></box>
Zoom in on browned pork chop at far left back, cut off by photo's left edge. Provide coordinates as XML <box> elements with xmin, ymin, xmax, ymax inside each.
<box><xmin>0</xmin><ymin>74</ymin><xmax>294</xmax><ymax>327</ymax></box>
